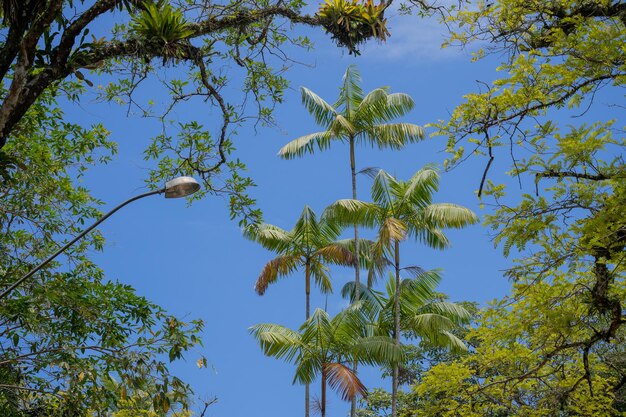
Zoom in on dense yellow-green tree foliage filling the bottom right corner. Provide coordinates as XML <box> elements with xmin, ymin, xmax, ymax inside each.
<box><xmin>414</xmin><ymin>272</ymin><xmax>624</xmax><ymax>416</ymax></box>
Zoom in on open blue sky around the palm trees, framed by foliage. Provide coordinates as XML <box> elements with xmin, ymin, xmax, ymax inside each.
<box><xmin>71</xmin><ymin>9</ymin><xmax>509</xmax><ymax>417</ymax></box>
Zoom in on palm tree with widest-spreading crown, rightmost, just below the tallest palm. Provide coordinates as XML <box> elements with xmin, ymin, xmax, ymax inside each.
<box><xmin>323</xmin><ymin>166</ymin><xmax>478</xmax><ymax>417</ymax></box>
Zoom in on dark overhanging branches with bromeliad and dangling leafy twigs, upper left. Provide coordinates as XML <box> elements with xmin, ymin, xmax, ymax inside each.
<box><xmin>0</xmin><ymin>0</ymin><xmax>319</xmax><ymax>223</ymax></box>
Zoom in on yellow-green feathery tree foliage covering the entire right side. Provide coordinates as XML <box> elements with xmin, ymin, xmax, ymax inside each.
<box><xmin>394</xmin><ymin>0</ymin><xmax>626</xmax><ymax>416</ymax></box>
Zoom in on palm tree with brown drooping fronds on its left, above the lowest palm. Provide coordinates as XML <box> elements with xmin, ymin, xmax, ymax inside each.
<box><xmin>244</xmin><ymin>206</ymin><xmax>355</xmax><ymax>417</ymax></box>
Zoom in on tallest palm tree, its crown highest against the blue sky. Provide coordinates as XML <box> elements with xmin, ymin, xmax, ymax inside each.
<box><xmin>278</xmin><ymin>66</ymin><xmax>424</xmax><ymax>300</ymax></box>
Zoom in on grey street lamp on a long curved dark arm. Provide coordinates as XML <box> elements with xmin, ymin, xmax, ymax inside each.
<box><xmin>0</xmin><ymin>177</ymin><xmax>200</xmax><ymax>300</ymax></box>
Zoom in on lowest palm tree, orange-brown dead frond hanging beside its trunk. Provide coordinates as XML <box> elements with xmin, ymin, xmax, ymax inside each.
<box><xmin>250</xmin><ymin>303</ymin><xmax>402</xmax><ymax>417</ymax></box>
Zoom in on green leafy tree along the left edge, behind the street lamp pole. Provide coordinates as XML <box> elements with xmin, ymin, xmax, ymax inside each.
<box><xmin>0</xmin><ymin>82</ymin><xmax>203</xmax><ymax>417</ymax></box>
